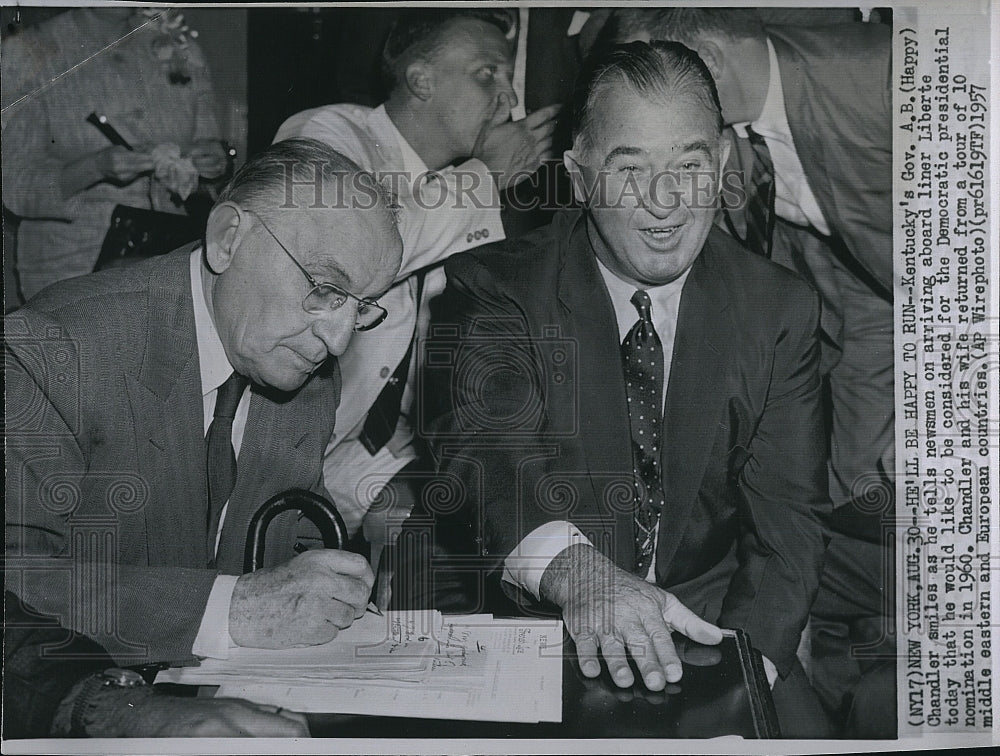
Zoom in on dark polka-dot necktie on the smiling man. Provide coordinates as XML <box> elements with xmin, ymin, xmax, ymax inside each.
<box><xmin>622</xmin><ymin>290</ymin><xmax>663</xmax><ymax>577</ymax></box>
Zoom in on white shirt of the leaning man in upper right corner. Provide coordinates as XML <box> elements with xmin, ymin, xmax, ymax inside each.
<box><xmin>733</xmin><ymin>39</ymin><xmax>830</xmax><ymax>236</ymax></box>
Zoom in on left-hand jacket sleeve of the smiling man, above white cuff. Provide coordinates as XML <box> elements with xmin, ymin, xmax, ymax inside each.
<box><xmin>420</xmin><ymin>250</ymin><xmax>565</xmax><ymax>568</ymax></box>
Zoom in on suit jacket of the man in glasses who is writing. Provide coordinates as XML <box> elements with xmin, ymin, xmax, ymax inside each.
<box><xmin>4</xmin><ymin>248</ymin><xmax>340</xmax><ymax>664</ymax></box>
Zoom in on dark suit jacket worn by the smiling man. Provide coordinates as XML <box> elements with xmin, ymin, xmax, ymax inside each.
<box><xmin>420</xmin><ymin>211</ymin><xmax>828</xmax><ymax>673</ymax></box>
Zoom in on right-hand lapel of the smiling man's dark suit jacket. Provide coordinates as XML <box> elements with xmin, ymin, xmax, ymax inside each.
<box><xmin>656</xmin><ymin>241</ymin><xmax>732</xmax><ymax>578</ymax></box>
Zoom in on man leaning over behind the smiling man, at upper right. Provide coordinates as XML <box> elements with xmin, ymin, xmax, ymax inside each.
<box><xmin>605</xmin><ymin>8</ymin><xmax>896</xmax><ymax>737</ymax></box>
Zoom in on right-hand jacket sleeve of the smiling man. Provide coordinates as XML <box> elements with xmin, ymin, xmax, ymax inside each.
<box><xmin>719</xmin><ymin>286</ymin><xmax>830</xmax><ymax>675</ymax></box>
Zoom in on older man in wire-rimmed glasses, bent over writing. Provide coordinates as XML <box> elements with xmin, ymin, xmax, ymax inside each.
<box><xmin>4</xmin><ymin>140</ymin><xmax>401</xmax><ymax>704</ymax></box>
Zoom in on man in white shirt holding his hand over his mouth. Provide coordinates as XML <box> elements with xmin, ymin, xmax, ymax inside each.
<box><xmin>275</xmin><ymin>9</ymin><xmax>555</xmax><ymax>549</ymax></box>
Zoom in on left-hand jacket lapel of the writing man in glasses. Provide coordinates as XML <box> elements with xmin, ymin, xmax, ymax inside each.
<box><xmin>125</xmin><ymin>248</ymin><xmax>207</xmax><ymax>567</ymax></box>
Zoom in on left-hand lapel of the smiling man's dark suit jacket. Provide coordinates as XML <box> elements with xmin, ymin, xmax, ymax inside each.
<box><xmin>558</xmin><ymin>214</ymin><xmax>635</xmax><ymax>565</ymax></box>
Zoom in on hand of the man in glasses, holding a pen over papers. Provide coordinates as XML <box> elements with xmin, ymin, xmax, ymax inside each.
<box><xmin>229</xmin><ymin>549</ymin><xmax>375</xmax><ymax>648</ymax></box>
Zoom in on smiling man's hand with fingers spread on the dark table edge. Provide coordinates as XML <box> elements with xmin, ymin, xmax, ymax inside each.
<box><xmin>540</xmin><ymin>544</ymin><xmax>722</xmax><ymax>690</ymax></box>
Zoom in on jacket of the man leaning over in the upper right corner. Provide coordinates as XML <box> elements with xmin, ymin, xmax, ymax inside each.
<box><xmin>767</xmin><ymin>23</ymin><xmax>893</xmax><ymax>298</ymax></box>
